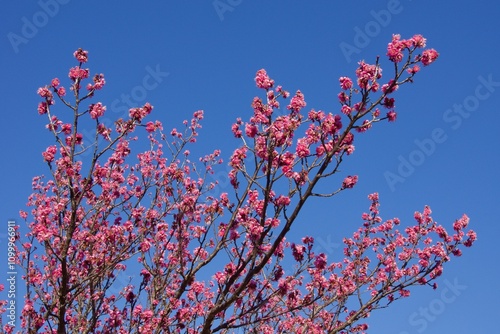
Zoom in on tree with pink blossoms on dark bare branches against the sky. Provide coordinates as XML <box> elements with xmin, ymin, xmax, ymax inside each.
<box><xmin>3</xmin><ymin>35</ymin><xmax>476</xmax><ymax>334</ymax></box>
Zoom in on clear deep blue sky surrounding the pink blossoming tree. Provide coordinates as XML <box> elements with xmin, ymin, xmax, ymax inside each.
<box><xmin>0</xmin><ymin>0</ymin><xmax>500</xmax><ymax>334</ymax></box>
